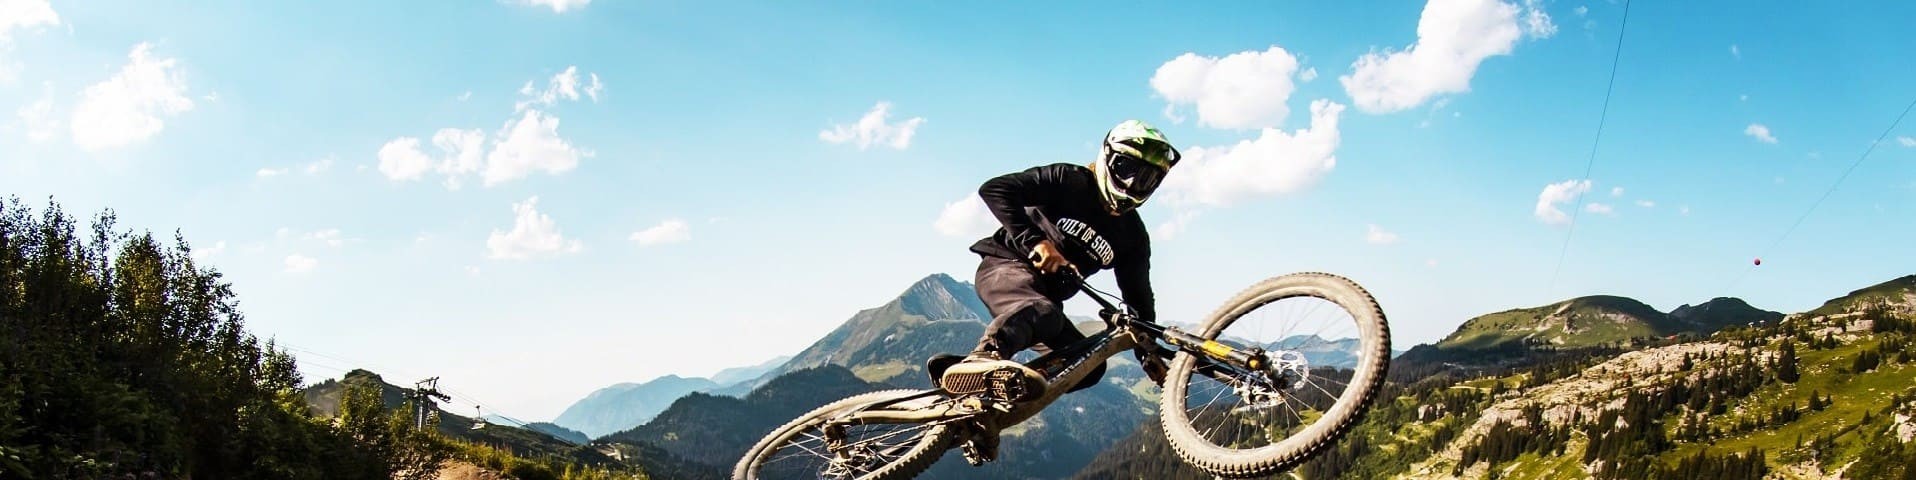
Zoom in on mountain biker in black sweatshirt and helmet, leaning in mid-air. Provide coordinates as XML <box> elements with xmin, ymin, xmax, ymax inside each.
<box><xmin>939</xmin><ymin>120</ymin><xmax>1178</xmax><ymax>400</ymax></box>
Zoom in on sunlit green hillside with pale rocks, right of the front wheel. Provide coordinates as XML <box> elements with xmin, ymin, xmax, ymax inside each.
<box><xmin>1077</xmin><ymin>275</ymin><xmax>1916</xmax><ymax>480</ymax></box>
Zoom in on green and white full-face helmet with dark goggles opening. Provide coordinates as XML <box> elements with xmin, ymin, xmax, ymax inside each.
<box><xmin>1092</xmin><ymin>120</ymin><xmax>1178</xmax><ymax>214</ymax></box>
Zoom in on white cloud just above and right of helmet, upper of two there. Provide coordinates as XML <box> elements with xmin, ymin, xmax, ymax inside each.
<box><xmin>1152</xmin><ymin>46</ymin><xmax>1297</xmax><ymax>128</ymax></box>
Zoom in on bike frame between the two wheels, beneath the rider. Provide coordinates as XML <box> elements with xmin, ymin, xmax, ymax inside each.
<box><xmin>833</xmin><ymin>277</ymin><xmax>1270</xmax><ymax>430</ymax></box>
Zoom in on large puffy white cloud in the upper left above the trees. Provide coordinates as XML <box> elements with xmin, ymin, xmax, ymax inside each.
<box><xmin>73</xmin><ymin>44</ymin><xmax>194</xmax><ymax>151</ymax></box>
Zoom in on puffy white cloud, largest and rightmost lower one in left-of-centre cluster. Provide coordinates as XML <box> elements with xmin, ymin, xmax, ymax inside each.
<box><xmin>481</xmin><ymin>111</ymin><xmax>590</xmax><ymax>187</ymax></box>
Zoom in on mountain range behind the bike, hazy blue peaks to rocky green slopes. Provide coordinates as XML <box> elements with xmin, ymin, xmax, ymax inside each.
<box><xmin>463</xmin><ymin>275</ymin><xmax>1916</xmax><ymax>478</ymax></box>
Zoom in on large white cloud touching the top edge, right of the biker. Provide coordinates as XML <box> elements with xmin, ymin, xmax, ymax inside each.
<box><xmin>1337</xmin><ymin>0</ymin><xmax>1556</xmax><ymax>113</ymax></box>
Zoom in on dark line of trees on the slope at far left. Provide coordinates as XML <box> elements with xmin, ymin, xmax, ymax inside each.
<box><xmin>0</xmin><ymin>197</ymin><xmax>639</xmax><ymax>480</ymax></box>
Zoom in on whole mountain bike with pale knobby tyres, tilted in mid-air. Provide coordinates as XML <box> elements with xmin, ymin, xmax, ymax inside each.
<box><xmin>732</xmin><ymin>273</ymin><xmax>1391</xmax><ymax>480</ymax></box>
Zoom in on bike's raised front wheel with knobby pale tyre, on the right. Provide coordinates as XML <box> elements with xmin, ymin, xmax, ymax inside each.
<box><xmin>1159</xmin><ymin>273</ymin><xmax>1391</xmax><ymax>478</ymax></box>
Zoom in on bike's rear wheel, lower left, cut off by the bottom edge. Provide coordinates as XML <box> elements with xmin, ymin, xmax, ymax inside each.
<box><xmin>732</xmin><ymin>390</ymin><xmax>956</xmax><ymax>480</ymax></box>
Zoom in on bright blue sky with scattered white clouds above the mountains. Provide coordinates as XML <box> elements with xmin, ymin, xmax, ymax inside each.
<box><xmin>0</xmin><ymin>0</ymin><xmax>1916</xmax><ymax>419</ymax></box>
